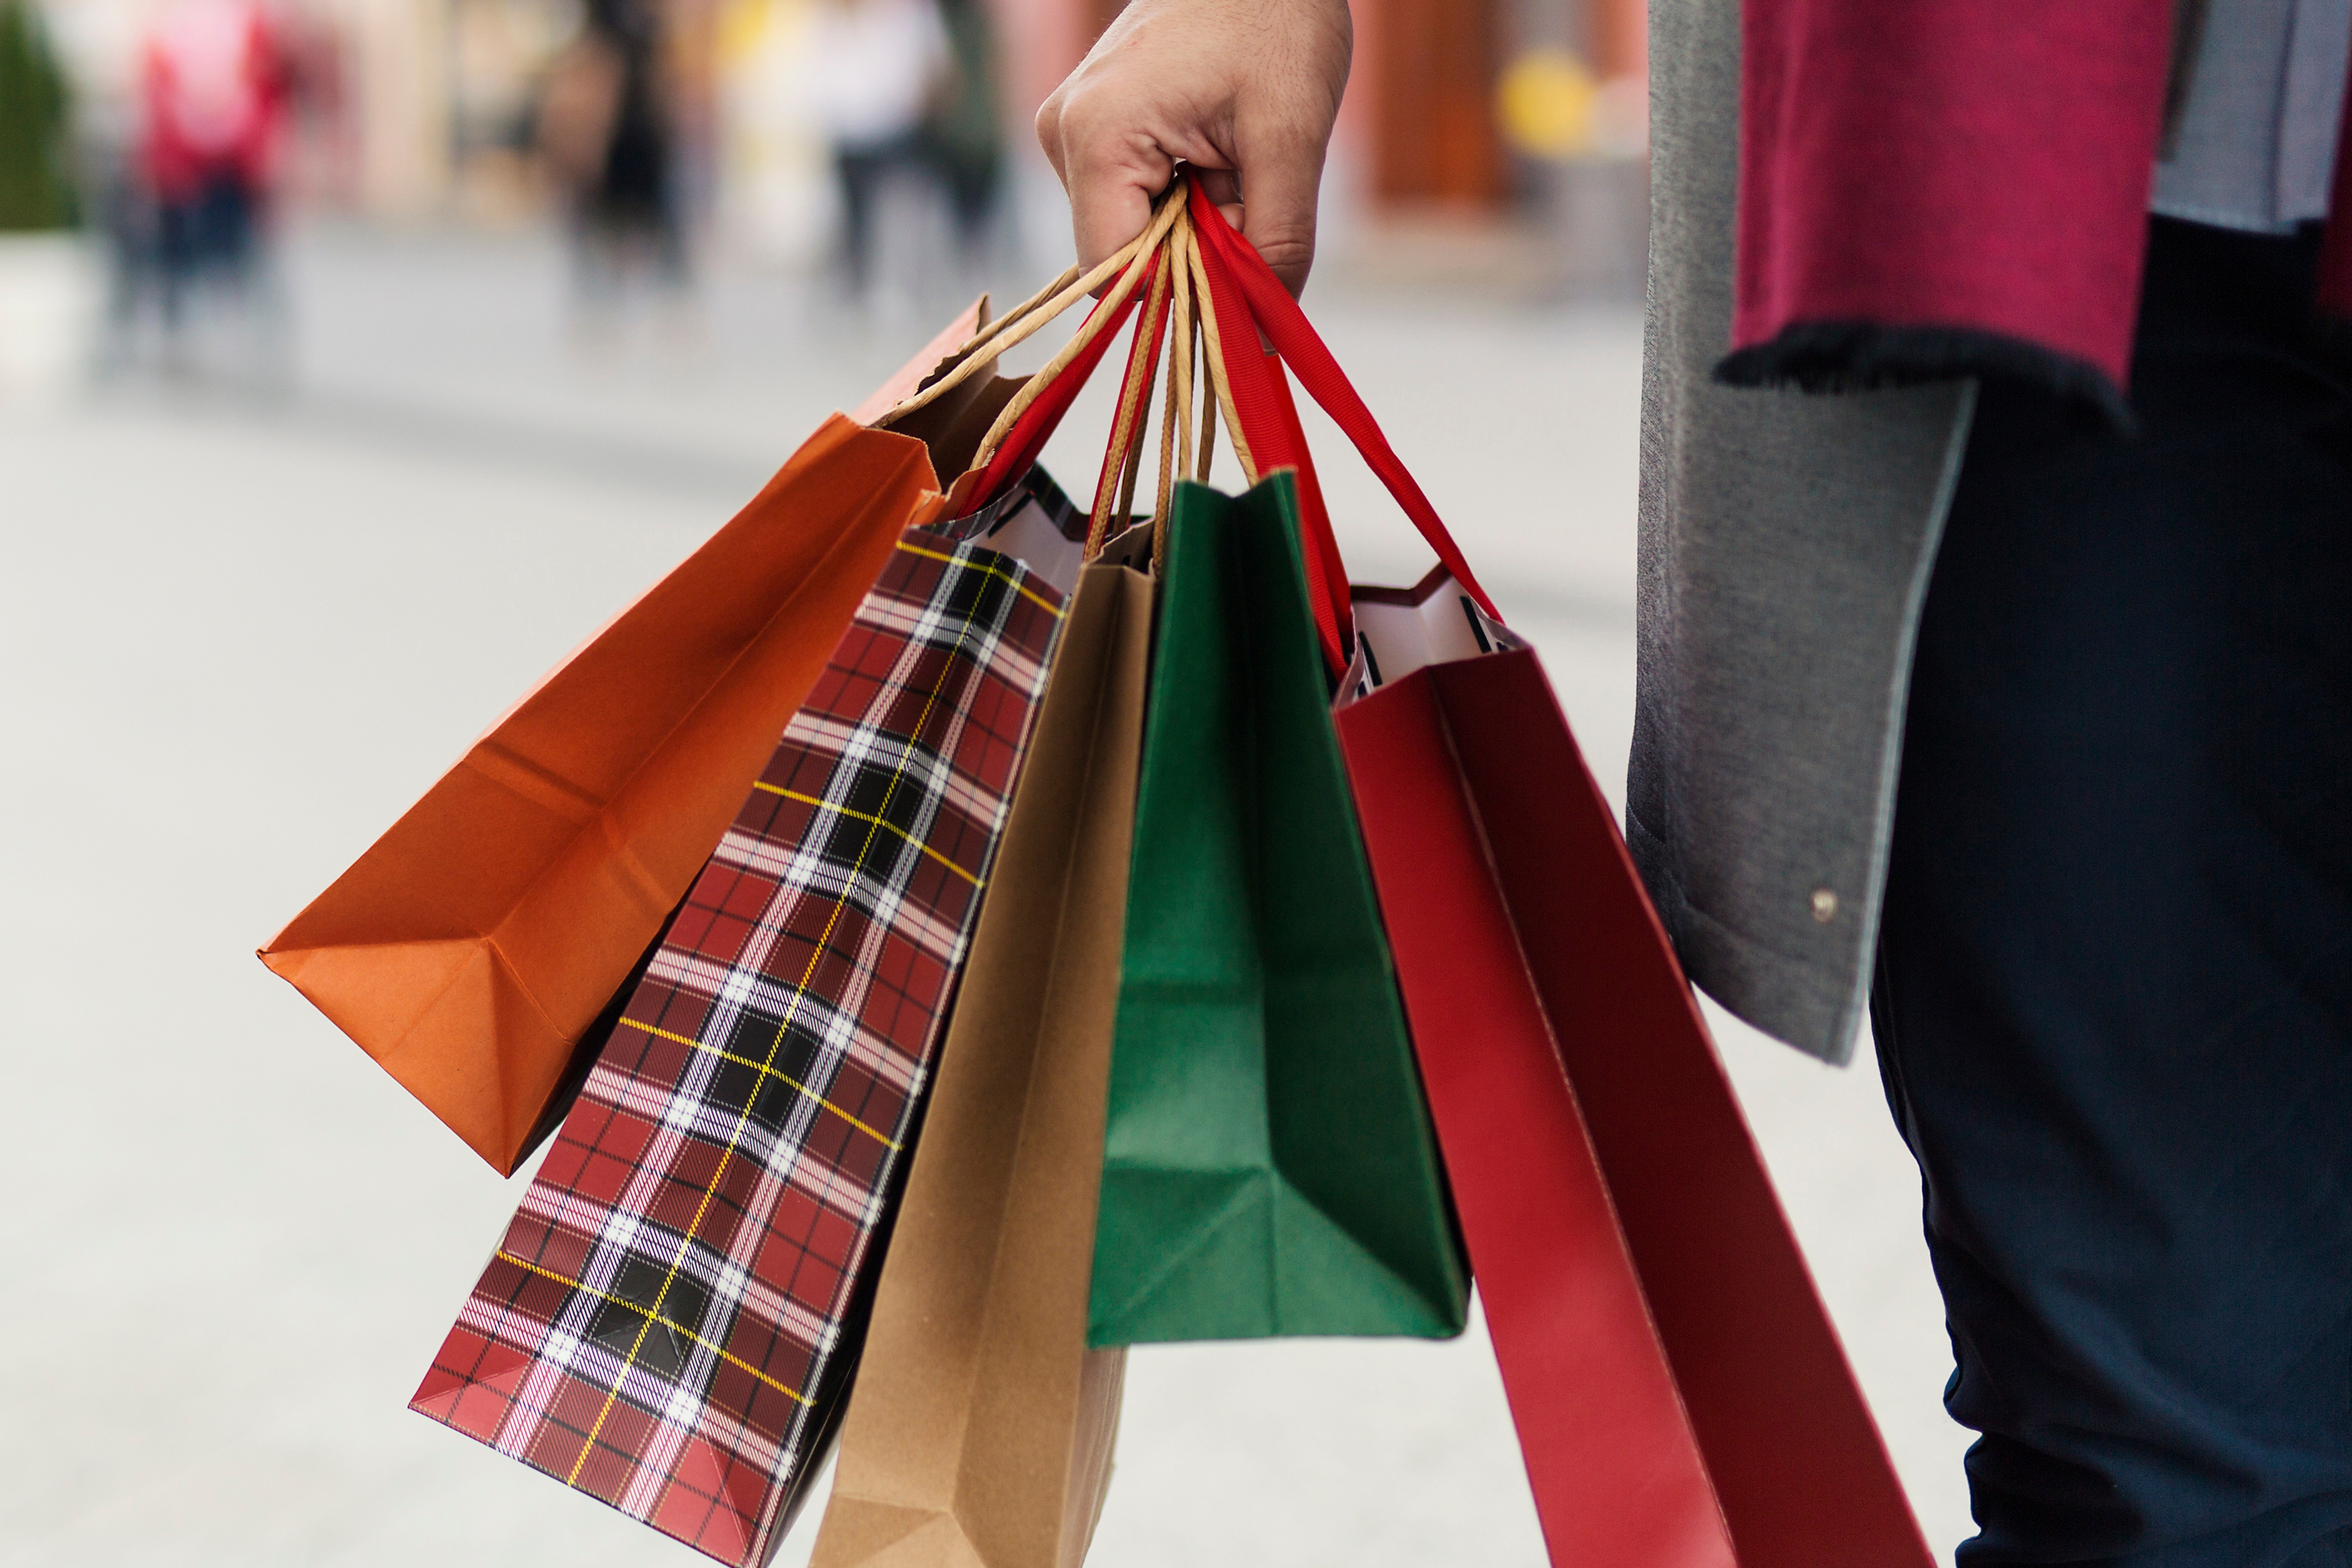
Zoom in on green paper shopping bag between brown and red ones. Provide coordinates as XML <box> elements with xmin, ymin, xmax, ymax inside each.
<box><xmin>1086</xmin><ymin>473</ymin><xmax>1468</xmax><ymax>1345</ymax></box>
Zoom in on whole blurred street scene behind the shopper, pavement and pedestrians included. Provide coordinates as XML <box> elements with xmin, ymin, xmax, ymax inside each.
<box><xmin>0</xmin><ymin>0</ymin><xmax>1969</xmax><ymax>1568</ymax></box>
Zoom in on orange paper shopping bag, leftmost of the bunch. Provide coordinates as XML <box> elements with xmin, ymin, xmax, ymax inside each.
<box><xmin>261</xmin><ymin>301</ymin><xmax>988</xmax><ymax>1173</ymax></box>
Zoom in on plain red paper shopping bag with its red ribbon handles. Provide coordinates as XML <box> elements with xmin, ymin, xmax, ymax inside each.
<box><xmin>1192</xmin><ymin>175</ymin><xmax>1931</xmax><ymax>1568</ymax></box>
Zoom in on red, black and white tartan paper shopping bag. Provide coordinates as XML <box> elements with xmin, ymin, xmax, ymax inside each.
<box><xmin>409</xmin><ymin>531</ymin><xmax>1061</xmax><ymax>1566</ymax></box>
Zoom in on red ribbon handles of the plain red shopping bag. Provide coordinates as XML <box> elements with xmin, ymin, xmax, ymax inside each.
<box><xmin>1185</xmin><ymin>174</ymin><xmax>1503</xmax><ymax>651</ymax></box>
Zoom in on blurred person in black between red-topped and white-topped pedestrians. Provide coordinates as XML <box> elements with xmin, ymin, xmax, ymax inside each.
<box><xmin>536</xmin><ymin>0</ymin><xmax>689</xmax><ymax>327</ymax></box>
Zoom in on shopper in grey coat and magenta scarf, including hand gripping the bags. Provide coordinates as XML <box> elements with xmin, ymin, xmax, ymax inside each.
<box><xmin>1037</xmin><ymin>0</ymin><xmax>2352</xmax><ymax>1568</ymax></box>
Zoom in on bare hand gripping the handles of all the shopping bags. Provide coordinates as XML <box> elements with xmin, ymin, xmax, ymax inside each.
<box><xmin>1037</xmin><ymin>0</ymin><xmax>1355</xmax><ymax>294</ymax></box>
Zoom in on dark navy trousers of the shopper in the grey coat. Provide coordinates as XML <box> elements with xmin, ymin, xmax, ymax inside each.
<box><xmin>1872</xmin><ymin>218</ymin><xmax>2352</xmax><ymax>1568</ymax></box>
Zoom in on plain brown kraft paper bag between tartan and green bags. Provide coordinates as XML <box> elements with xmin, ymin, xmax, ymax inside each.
<box><xmin>812</xmin><ymin>552</ymin><xmax>1150</xmax><ymax>1568</ymax></box>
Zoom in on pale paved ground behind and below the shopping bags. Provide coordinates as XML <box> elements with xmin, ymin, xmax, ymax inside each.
<box><xmin>0</xmin><ymin>223</ymin><xmax>1966</xmax><ymax>1568</ymax></box>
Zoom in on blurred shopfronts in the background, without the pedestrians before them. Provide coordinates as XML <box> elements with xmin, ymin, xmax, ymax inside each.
<box><xmin>23</xmin><ymin>0</ymin><xmax>1646</xmax><ymax>287</ymax></box>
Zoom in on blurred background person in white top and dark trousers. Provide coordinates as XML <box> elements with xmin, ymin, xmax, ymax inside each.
<box><xmin>809</xmin><ymin>0</ymin><xmax>950</xmax><ymax>296</ymax></box>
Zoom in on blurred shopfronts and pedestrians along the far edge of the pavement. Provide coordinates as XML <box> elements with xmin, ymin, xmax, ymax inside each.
<box><xmin>0</xmin><ymin>0</ymin><xmax>1646</xmax><ymax>400</ymax></box>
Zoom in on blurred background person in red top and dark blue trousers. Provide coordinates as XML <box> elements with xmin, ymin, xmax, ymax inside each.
<box><xmin>139</xmin><ymin>0</ymin><xmax>287</xmax><ymax>334</ymax></box>
